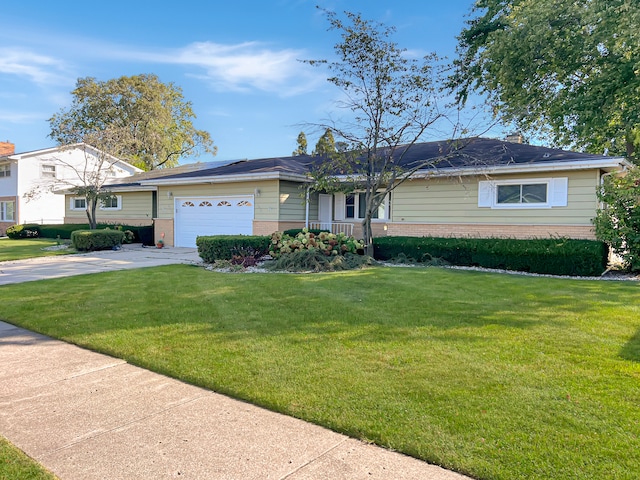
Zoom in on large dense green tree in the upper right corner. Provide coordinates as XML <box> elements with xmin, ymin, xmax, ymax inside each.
<box><xmin>448</xmin><ymin>0</ymin><xmax>640</xmax><ymax>161</ymax></box>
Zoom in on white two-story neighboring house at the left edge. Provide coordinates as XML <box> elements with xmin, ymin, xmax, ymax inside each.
<box><xmin>0</xmin><ymin>143</ymin><xmax>142</xmax><ymax>235</ymax></box>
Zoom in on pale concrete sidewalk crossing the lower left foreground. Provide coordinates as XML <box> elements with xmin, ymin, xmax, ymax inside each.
<box><xmin>0</xmin><ymin>322</ymin><xmax>467</xmax><ymax>480</ymax></box>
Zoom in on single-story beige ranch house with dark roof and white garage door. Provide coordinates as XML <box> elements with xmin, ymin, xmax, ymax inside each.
<box><xmin>65</xmin><ymin>138</ymin><xmax>630</xmax><ymax>247</ymax></box>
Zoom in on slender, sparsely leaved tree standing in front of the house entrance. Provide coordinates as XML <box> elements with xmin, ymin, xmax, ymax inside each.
<box><xmin>305</xmin><ymin>11</ymin><xmax>441</xmax><ymax>255</ymax></box>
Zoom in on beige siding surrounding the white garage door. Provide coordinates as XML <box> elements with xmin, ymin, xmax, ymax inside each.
<box><xmin>158</xmin><ymin>180</ymin><xmax>280</xmax><ymax>220</ymax></box>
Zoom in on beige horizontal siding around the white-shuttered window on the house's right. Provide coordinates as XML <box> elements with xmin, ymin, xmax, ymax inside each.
<box><xmin>391</xmin><ymin>170</ymin><xmax>599</xmax><ymax>225</ymax></box>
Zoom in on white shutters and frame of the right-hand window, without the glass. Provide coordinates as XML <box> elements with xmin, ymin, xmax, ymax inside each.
<box><xmin>478</xmin><ymin>177</ymin><xmax>569</xmax><ymax>210</ymax></box>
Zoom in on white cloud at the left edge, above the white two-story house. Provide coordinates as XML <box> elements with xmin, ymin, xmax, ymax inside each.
<box><xmin>0</xmin><ymin>48</ymin><xmax>69</xmax><ymax>85</ymax></box>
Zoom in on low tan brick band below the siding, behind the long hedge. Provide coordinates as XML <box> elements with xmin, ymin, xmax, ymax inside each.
<box><xmin>386</xmin><ymin>223</ymin><xmax>596</xmax><ymax>240</ymax></box>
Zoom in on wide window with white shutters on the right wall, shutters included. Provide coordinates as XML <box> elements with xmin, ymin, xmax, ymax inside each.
<box><xmin>478</xmin><ymin>177</ymin><xmax>569</xmax><ymax>208</ymax></box>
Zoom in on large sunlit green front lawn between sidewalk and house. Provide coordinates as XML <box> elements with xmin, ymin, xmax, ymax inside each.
<box><xmin>0</xmin><ymin>265</ymin><xmax>640</xmax><ymax>480</ymax></box>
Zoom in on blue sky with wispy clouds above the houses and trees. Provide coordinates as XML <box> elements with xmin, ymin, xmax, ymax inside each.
<box><xmin>0</xmin><ymin>0</ymin><xmax>503</xmax><ymax>161</ymax></box>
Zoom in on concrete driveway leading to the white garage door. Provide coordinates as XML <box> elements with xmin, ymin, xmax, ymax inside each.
<box><xmin>0</xmin><ymin>244</ymin><xmax>202</xmax><ymax>285</ymax></box>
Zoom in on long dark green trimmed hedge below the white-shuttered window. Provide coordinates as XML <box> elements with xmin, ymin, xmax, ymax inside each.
<box><xmin>374</xmin><ymin>237</ymin><xmax>609</xmax><ymax>276</ymax></box>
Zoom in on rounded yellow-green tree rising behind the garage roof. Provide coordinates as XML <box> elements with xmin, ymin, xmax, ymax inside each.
<box><xmin>49</xmin><ymin>75</ymin><xmax>216</xmax><ymax>170</ymax></box>
